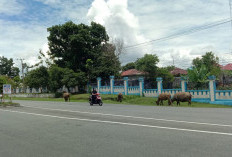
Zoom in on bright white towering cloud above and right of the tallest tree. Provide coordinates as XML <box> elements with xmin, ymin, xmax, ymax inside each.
<box><xmin>87</xmin><ymin>0</ymin><xmax>151</xmax><ymax>62</ymax></box>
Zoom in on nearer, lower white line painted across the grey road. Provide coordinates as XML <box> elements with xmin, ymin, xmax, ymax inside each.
<box><xmin>0</xmin><ymin>109</ymin><xmax>232</xmax><ymax>136</ymax></box>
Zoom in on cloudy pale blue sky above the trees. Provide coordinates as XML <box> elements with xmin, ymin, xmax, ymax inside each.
<box><xmin>0</xmin><ymin>0</ymin><xmax>232</xmax><ymax>69</ymax></box>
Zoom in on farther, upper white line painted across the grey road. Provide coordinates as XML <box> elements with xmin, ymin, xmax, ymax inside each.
<box><xmin>24</xmin><ymin>105</ymin><xmax>232</xmax><ymax>127</ymax></box>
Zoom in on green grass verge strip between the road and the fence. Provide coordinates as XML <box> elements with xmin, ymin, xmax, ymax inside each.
<box><xmin>12</xmin><ymin>94</ymin><xmax>232</xmax><ymax>108</ymax></box>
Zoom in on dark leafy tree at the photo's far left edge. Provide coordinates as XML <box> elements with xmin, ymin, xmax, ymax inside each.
<box><xmin>0</xmin><ymin>56</ymin><xmax>19</xmax><ymax>78</ymax></box>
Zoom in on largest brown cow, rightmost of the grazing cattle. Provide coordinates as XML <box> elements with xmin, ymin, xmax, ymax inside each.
<box><xmin>172</xmin><ymin>92</ymin><xmax>192</xmax><ymax>105</ymax></box>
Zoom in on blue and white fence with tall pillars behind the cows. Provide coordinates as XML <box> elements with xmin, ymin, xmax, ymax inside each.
<box><xmin>97</xmin><ymin>76</ymin><xmax>232</xmax><ymax>105</ymax></box>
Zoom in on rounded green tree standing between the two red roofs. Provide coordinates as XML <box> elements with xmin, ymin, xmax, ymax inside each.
<box><xmin>135</xmin><ymin>54</ymin><xmax>159</xmax><ymax>77</ymax></box>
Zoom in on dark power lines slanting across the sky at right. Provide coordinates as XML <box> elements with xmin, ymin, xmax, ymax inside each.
<box><xmin>124</xmin><ymin>18</ymin><xmax>232</xmax><ymax>49</ymax></box>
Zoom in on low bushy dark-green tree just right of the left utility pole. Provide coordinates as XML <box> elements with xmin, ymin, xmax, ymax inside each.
<box><xmin>25</xmin><ymin>66</ymin><xmax>49</xmax><ymax>89</ymax></box>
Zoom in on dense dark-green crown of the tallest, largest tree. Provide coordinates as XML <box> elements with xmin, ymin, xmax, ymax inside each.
<box><xmin>48</xmin><ymin>21</ymin><xmax>120</xmax><ymax>81</ymax></box>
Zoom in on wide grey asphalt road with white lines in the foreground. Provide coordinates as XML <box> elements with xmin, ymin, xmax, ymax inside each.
<box><xmin>0</xmin><ymin>101</ymin><xmax>232</xmax><ymax>157</ymax></box>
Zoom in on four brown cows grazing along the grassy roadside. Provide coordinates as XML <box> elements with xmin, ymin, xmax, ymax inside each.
<box><xmin>63</xmin><ymin>92</ymin><xmax>192</xmax><ymax>105</ymax></box>
